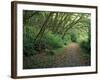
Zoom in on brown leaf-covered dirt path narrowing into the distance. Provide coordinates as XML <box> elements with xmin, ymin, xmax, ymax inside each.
<box><xmin>55</xmin><ymin>42</ymin><xmax>86</xmax><ymax>66</ymax></box>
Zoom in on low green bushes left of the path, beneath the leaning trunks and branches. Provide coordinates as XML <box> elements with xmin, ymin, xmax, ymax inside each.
<box><xmin>23</xmin><ymin>26</ymin><xmax>63</xmax><ymax>56</ymax></box>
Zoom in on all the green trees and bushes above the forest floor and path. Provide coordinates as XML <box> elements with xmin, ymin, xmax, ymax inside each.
<box><xmin>23</xmin><ymin>10</ymin><xmax>91</xmax><ymax>67</ymax></box>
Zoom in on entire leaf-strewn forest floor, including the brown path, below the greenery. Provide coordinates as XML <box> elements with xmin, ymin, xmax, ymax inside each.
<box><xmin>23</xmin><ymin>43</ymin><xmax>90</xmax><ymax>69</ymax></box>
